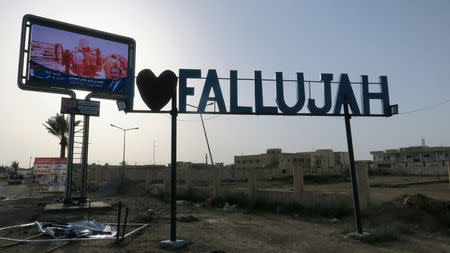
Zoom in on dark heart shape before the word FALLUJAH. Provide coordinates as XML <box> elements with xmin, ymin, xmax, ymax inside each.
<box><xmin>136</xmin><ymin>69</ymin><xmax>178</xmax><ymax>112</ymax></box>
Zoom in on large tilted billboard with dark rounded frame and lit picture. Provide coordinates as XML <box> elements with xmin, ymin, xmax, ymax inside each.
<box><xmin>19</xmin><ymin>15</ymin><xmax>136</xmax><ymax>109</ymax></box>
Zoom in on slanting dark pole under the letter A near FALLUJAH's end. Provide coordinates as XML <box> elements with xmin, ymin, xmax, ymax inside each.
<box><xmin>344</xmin><ymin>104</ymin><xmax>362</xmax><ymax>234</ymax></box>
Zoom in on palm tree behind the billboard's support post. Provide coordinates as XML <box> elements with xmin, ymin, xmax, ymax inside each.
<box><xmin>43</xmin><ymin>113</ymin><xmax>80</xmax><ymax>158</ymax></box>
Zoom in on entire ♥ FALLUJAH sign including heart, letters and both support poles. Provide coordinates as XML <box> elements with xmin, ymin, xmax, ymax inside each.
<box><xmin>132</xmin><ymin>69</ymin><xmax>398</xmax><ymax>243</ymax></box>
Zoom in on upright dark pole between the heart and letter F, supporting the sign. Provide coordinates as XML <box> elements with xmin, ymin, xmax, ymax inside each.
<box><xmin>170</xmin><ymin>91</ymin><xmax>178</xmax><ymax>242</ymax></box>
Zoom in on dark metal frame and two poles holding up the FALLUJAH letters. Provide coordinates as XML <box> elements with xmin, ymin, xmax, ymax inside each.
<box><xmin>129</xmin><ymin>70</ymin><xmax>398</xmax><ymax>241</ymax></box>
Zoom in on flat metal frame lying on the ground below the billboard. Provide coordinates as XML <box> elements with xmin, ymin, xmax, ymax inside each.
<box><xmin>0</xmin><ymin>223</ymin><xmax>148</xmax><ymax>243</ymax></box>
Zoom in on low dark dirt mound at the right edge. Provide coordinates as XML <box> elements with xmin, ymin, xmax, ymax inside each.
<box><xmin>368</xmin><ymin>194</ymin><xmax>450</xmax><ymax>233</ymax></box>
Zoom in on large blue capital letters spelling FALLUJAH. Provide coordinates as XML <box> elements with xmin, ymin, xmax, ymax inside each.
<box><xmin>179</xmin><ymin>69</ymin><xmax>392</xmax><ymax>116</ymax></box>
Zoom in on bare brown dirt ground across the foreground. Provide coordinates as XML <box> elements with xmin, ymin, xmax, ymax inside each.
<box><xmin>0</xmin><ymin>181</ymin><xmax>450</xmax><ymax>253</ymax></box>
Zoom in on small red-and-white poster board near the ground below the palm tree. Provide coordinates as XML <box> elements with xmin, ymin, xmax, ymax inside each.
<box><xmin>34</xmin><ymin>157</ymin><xmax>67</xmax><ymax>192</ymax></box>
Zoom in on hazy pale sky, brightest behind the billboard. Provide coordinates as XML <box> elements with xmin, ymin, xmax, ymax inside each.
<box><xmin>0</xmin><ymin>0</ymin><xmax>450</xmax><ymax>168</ymax></box>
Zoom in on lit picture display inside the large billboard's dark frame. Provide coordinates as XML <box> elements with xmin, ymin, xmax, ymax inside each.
<box><xmin>29</xmin><ymin>24</ymin><xmax>133</xmax><ymax>94</ymax></box>
